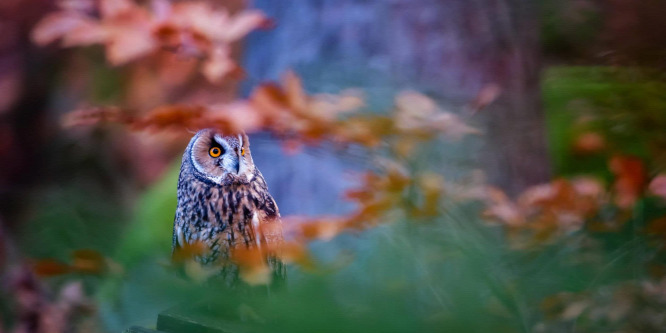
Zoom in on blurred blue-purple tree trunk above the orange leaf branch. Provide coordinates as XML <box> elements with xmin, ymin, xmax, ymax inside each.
<box><xmin>244</xmin><ymin>0</ymin><xmax>550</xmax><ymax>208</ymax></box>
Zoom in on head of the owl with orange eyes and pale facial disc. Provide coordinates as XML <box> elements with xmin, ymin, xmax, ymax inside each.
<box><xmin>183</xmin><ymin>129</ymin><xmax>255</xmax><ymax>185</ymax></box>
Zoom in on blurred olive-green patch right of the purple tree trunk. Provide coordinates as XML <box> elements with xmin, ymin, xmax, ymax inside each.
<box><xmin>543</xmin><ymin>67</ymin><xmax>666</xmax><ymax>178</ymax></box>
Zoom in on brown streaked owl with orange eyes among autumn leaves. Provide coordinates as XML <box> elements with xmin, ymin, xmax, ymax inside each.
<box><xmin>172</xmin><ymin>129</ymin><xmax>284</xmax><ymax>276</ymax></box>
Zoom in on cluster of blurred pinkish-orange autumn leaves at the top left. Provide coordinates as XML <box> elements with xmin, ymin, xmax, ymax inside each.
<box><xmin>32</xmin><ymin>0</ymin><xmax>268</xmax><ymax>83</ymax></box>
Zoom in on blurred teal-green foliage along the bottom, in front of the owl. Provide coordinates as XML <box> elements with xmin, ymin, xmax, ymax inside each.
<box><xmin>102</xmin><ymin>195</ymin><xmax>664</xmax><ymax>332</ymax></box>
